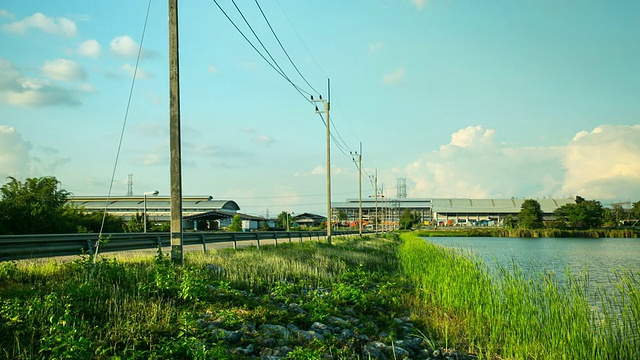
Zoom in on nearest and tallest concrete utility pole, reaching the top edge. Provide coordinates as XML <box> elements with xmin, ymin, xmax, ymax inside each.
<box><xmin>169</xmin><ymin>0</ymin><xmax>184</xmax><ymax>264</ymax></box>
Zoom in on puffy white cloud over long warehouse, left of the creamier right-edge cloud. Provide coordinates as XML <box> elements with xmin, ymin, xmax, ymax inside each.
<box><xmin>406</xmin><ymin>126</ymin><xmax>563</xmax><ymax>198</ymax></box>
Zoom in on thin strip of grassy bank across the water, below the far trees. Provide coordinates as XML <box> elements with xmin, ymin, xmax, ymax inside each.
<box><xmin>416</xmin><ymin>227</ymin><xmax>640</xmax><ymax>238</ymax></box>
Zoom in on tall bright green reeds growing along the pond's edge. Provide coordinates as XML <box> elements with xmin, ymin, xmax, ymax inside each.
<box><xmin>399</xmin><ymin>234</ymin><xmax>640</xmax><ymax>359</ymax></box>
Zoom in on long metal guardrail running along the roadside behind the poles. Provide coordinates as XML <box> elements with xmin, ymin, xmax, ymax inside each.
<box><xmin>0</xmin><ymin>231</ymin><xmax>358</xmax><ymax>261</ymax></box>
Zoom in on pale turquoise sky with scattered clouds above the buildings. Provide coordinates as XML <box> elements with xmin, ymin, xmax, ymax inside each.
<box><xmin>0</xmin><ymin>0</ymin><xmax>640</xmax><ymax>216</ymax></box>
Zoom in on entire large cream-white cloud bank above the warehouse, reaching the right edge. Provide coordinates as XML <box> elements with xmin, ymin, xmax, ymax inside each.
<box><xmin>405</xmin><ymin>125</ymin><xmax>640</xmax><ymax>200</ymax></box>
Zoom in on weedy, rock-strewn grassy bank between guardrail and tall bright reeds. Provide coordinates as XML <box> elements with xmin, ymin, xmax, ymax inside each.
<box><xmin>0</xmin><ymin>238</ymin><xmax>436</xmax><ymax>359</ymax></box>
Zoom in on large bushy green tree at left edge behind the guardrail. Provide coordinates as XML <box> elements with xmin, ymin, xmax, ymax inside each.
<box><xmin>0</xmin><ymin>176</ymin><xmax>69</xmax><ymax>234</ymax></box>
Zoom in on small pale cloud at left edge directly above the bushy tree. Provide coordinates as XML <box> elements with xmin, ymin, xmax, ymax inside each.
<box><xmin>0</xmin><ymin>125</ymin><xmax>31</xmax><ymax>180</ymax></box>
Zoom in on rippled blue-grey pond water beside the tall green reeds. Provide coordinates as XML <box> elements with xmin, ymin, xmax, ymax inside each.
<box><xmin>426</xmin><ymin>237</ymin><xmax>640</xmax><ymax>346</ymax></box>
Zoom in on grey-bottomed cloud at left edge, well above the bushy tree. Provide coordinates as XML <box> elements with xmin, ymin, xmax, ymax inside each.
<box><xmin>0</xmin><ymin>58</ymin><xmax>80</xmax><ymax>107</ymax></box>
